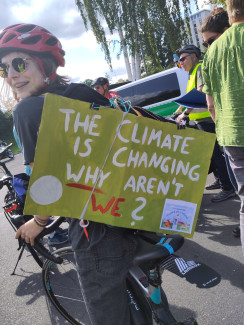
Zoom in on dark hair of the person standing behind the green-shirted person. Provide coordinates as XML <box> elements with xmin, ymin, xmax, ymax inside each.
<box><xmin>199</xmin><ymin>8</ymin><xmax>230</xmax><ymax>34</ymax></box>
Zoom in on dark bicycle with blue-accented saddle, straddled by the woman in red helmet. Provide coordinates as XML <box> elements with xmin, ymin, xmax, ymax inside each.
<box><xmin>42</xmin><ymin>231</ymin><xmax>197</xmax><ymax>325</ymax></box>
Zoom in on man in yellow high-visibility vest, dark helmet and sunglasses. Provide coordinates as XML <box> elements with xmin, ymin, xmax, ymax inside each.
<box><xmin>177</xmin><ymin>44</ymin><xmax>236</xmax><ymax>203</ymax></box>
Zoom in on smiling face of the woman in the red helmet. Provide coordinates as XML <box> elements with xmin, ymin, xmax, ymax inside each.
<box><xmin>2</xmin><ymin>52</ymin><xmax>44</xmax><ymax>99</ymax></box>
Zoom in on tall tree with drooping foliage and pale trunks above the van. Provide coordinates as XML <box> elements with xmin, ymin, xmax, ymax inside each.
<box><xmin>76</xmin><ymin>0</ymin><xmax>197</xmax><ymax>80</ymax></box>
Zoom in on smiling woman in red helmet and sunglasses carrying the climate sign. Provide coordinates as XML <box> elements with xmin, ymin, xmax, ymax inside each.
<box><xmin>0</xmin><ymin>24</ymin><xmax>135</xmax><ymax>325</ymax></box>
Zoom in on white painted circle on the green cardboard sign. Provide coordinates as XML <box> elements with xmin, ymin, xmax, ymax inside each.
<box><xmin>30</xmin><ymin>175</ymin><xmax>63</xmax><ymax>205</ymax></box>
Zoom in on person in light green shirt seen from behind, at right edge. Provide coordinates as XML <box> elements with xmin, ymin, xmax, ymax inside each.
<box><xmin>202</xmin><ymin>0</ymin><xmax>244</xmax><ymax>254</ymax></box>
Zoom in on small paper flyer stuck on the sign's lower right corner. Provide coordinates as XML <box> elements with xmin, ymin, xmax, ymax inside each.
<box><xmin>160</xmin><ymin>199</ymin><xmax>197</xmax><ymax>234</ymax></box>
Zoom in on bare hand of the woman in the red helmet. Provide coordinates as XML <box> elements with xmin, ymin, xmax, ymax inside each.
<box><xmin>15</xmin><ymin>218</ymin><xmax>44</xmax><ymax>246</ymax></box>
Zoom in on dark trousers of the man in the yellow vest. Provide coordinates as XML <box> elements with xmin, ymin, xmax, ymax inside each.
<box><xmin>197</xmin><ymin>122</ymin><xmax>233</xmax><ymax>191</ymax></box>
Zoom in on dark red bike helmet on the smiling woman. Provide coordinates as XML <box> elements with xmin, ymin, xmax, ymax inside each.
<box><xmin>0</xmin><ymin>24</ymin><xmax>65</xmax><ymax>67</ymax></box>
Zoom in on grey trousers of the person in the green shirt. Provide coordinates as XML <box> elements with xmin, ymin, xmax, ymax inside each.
<box><xmin>225</xmin><ymin>146</ymin><xmax>244</xmax><ymax>255</ymax></box>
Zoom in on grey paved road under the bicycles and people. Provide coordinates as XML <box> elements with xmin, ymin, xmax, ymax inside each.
<box><xmin>0</xmin><ymin>155</ymin><xmax>244</xmax><ymax>325</ymax></box>
